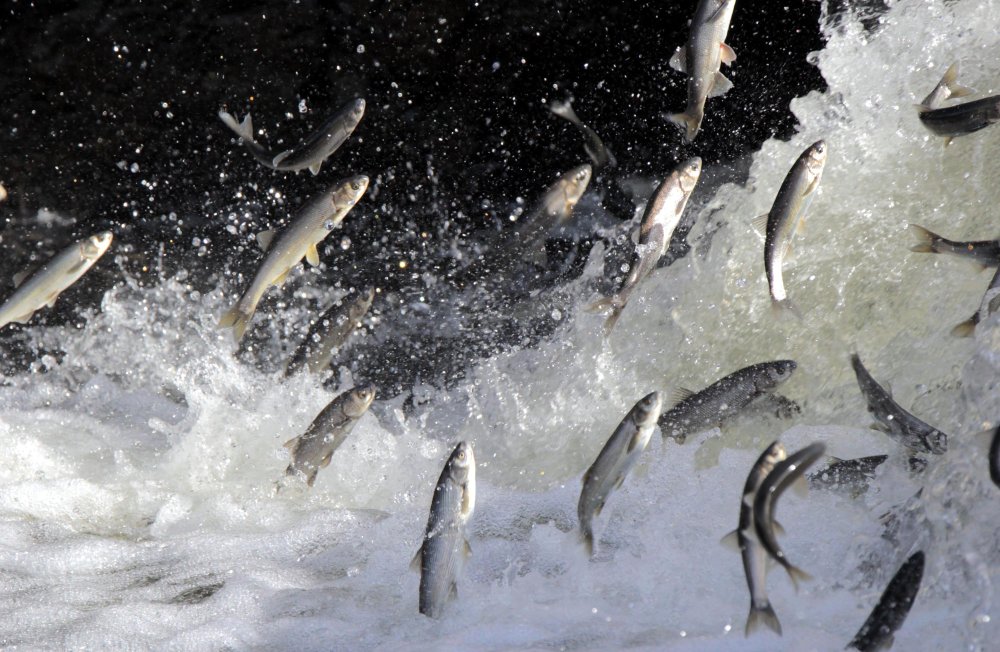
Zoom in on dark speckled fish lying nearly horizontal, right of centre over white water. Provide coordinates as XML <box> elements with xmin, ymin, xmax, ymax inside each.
<box><xmin>659</xmin><ymin>360</ymin><xmax>798</xmax><ymax>444</ymax></box>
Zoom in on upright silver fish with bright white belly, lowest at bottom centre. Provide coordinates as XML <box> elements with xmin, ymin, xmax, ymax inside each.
<box><xmin>410</xmin><ymin>441</ymin><xmax>476</xmax><ymax>618</ymax></box>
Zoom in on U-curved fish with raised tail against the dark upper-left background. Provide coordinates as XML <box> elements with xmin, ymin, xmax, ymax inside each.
<box><xmin>219</xmin><ymin>98</ymin><xmax>365</xmax><ymax>175</ymax></box>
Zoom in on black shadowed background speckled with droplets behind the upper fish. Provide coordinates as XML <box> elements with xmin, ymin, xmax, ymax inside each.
<box><xmin>0</xmin><ymin>0</ymin><xmax>824</xmax><ymax>386</ymax></box>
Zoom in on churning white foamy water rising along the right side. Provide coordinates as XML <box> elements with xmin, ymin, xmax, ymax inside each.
<box><xmin>0</xmin><ymin>0</ymin><xmax>1000</xmax><ymax>650</ymax></box>
